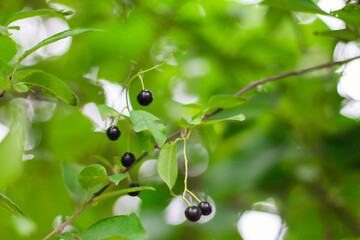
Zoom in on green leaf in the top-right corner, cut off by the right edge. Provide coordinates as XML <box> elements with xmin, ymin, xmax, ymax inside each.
<box><xmin>330</xmin><ymin>3</ymin><xmax>360</xmax><ymax>29</ymax></box>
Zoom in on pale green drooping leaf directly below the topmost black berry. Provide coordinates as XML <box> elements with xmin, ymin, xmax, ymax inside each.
<box><xmin>130</xmin><ymin>110</ymin><xmax>166</xmax><ymax>146</ymax></box>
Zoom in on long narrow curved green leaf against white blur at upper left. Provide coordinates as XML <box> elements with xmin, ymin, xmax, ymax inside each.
<box><xmin>17</xmin><ymin>28</ymin><xmax>99</xmax><ymax>65</ymax></box>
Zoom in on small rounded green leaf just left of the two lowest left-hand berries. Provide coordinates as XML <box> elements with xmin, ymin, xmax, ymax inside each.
<box><xmin>78</xmin><ymin>164</ymin><xmax>109</xmax><ymax>190</ymax></box>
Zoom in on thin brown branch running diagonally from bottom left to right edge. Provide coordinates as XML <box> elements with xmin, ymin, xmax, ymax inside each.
<box><xmin>44</xmin><ymin>56</ymin><xmax>360</xmax><ymax>240</ymax></box>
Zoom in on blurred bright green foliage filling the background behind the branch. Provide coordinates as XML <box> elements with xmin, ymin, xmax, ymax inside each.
<box><xmin>0</xmin><ymin>0</ymin><xmax>360</xmax><ymax>240</ymax></box>
